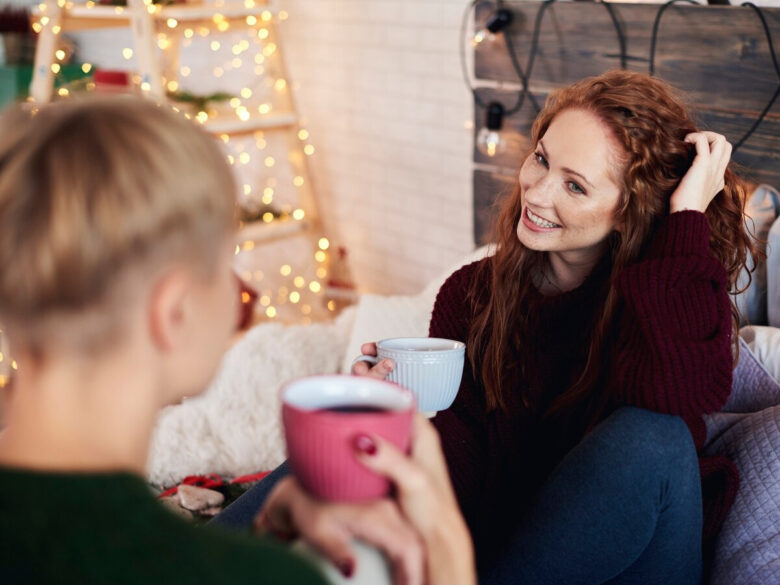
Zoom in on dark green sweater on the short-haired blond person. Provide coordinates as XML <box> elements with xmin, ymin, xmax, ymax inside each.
<box><xmin>0</xmin><ymin>467</ymin><xmax>325</xmax><ymax>585</ymax></box>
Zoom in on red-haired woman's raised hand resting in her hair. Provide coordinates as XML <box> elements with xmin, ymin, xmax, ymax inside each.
<box><xmin>669</xmin><ymin>131</ymin><xmax>731</xmax><ymax>213</ymax></box>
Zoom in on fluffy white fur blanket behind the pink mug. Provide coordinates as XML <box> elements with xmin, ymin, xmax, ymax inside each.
<box><xmin>147</xmin><ymin>308</ymin><xmax>354</xmax><ymax>486</ymax></box>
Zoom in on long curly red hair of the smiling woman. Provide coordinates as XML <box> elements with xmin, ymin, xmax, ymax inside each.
<box><xmin>469</xmin><ymin>71</ymin><xmax>756</xmax><ymax>409</ymax></box>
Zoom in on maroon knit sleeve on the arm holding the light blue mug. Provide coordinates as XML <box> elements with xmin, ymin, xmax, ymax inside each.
<box><xmin>428</xmin><ymin>260</ymin><xmax>486</xmax><ymax>516</ymax></box>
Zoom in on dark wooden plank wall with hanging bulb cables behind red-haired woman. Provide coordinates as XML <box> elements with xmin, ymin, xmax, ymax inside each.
<box><xmin>474</xmin><ymin>2</ymin><xmax>780</xmax><ymax>243</ymax></box>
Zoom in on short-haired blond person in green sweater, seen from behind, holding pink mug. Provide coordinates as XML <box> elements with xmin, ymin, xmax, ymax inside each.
<box><xmin>0</xmin><ymin>98</ymin><xmax>470</xmax><ymax>585</ymax></box>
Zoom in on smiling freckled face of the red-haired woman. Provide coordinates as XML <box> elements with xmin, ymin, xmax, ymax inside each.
<box><xmin>517</xmin><ymin>109</ymin><xmax>623</xmax><ymax>261</ymax></box>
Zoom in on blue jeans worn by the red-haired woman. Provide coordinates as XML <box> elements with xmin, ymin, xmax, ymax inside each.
<box><xmin>214</xmin><ymin>408</ymin><xmax>702</xmax><ymax>585</ymax></box>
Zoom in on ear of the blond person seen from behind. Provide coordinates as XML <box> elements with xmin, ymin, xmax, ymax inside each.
<box><xmin>147</xmin><ymin>269</ymin><xmax>193</xmax><ymax>351</ymax></box>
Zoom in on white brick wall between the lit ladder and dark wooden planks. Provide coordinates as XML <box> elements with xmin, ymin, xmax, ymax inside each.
<box><xmin>280</xmin><ymin>0</ymin><xmax>473</xmax><ymax>293</ymax></box>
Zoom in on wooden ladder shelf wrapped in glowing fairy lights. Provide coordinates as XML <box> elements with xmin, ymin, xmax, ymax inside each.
<box><xmin>30</xmin><ymin>0</ymin><xmax>333</xmax><ymax>322</ymax></box>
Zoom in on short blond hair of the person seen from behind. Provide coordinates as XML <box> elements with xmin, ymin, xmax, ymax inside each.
<box><xmin>0</xmin><ymin>96</ymin><xmax>236</xmax><ymax>347</ymax></box>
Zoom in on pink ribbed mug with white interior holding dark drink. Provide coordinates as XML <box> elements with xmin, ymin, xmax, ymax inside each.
<box><xmin>282</xmin><ymin>375</ymin><xmax>415</xmax><ymax>502</ymax></box>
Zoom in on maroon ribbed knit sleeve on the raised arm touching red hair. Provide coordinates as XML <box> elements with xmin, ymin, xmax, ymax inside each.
<box><xmin>612</xmin><ymin>211</ymin><xmax>733</xmax><ymax>447</ymax></box>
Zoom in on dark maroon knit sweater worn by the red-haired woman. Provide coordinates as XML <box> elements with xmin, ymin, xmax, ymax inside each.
<box><xmin>429</xmin><ymin>211</ymin><xmax>738</xmax><ymax>567</ymax></box>
